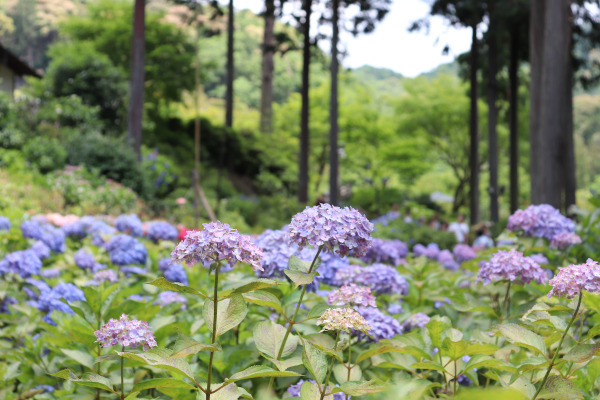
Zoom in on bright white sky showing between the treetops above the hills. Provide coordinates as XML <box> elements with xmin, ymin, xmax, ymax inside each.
<box><xmin>236</xmin><ymin>0</ymin><xmax>471</xmax><ymax>77</ymax></box>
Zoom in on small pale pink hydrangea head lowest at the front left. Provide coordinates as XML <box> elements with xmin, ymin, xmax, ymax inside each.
<box><xmin>94</xmin><ymin>314</ymin><xmax>157</xmax><ymax>351</ymax></box>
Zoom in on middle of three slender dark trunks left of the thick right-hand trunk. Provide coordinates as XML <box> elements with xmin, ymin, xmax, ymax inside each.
<box><xmin>487</xmin><ymin>10</ymin><xmax>498</xmax><ymax>223</ymax></box>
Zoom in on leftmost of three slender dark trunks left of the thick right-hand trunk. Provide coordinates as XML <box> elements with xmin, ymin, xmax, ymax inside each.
<box><xmin>469</xmin><ymin>23</ymin><xmax>479</xmax><ymax>225</ymax></box>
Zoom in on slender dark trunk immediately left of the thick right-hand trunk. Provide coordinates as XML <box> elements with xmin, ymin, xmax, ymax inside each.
<box><xmin>508</xmin><ymin>26</ymin><xmax>519</xmax><ymax>214</ymax></box>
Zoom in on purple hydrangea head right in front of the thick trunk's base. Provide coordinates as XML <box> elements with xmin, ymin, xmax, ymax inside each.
<box><xmin>506</xmin><ymin>204</ymin><xmax>575</xmax><ymax>240</ymax></box>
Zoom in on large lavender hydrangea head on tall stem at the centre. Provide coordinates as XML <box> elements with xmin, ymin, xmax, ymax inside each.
<box><xmin>289</xmin><ymin>204</ymin><xmax>373</xmax><ymax>257</ymax></box>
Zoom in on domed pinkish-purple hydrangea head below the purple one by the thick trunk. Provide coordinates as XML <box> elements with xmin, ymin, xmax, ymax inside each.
<box><xmin>477</xmin><ymin>250</ymin><xmax>548</xmax><ymax>285</ymax></box>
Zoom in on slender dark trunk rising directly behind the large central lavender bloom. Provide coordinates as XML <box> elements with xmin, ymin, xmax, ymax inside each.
<box><xmin>329</xmin><ymin>0</ymin><xmax>340</xmax><ymax>206</ymax></box>
